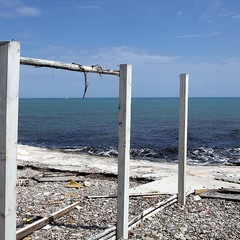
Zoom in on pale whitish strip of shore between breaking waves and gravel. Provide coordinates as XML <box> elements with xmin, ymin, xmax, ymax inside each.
<box><xmin>17</xmin><ymin>145</ymin><xmax>240</xmax><ymax>180</ymax></box>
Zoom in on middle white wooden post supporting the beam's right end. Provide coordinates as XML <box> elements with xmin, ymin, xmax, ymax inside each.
<box><xmin>117</xmin><ymin>64</ymin><xmax>132</xmax><ymax>239</ymax></box>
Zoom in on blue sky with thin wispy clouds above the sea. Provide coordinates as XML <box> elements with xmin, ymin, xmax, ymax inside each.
<box><xmin>0</xmin><ymin>0</ymin><xmax>240</xmax><ymax>98</ymax></box>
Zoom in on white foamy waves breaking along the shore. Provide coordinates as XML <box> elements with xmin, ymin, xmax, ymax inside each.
<box><xmin>59</xmin><ymin>147</ymin><xmax>240</xmax><ymax>165</ymax></box>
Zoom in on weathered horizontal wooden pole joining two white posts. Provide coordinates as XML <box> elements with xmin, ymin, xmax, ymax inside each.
<box><xmin>20</xmin><ymin>57</ymin><xmax>120</xmax><ymax>76</ymax></box>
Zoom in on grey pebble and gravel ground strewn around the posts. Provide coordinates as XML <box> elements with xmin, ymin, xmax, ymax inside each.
<box><xmin>17</xmin><ymin>168</ymin><xmax>240</xmax><ymax>240</ymax></box>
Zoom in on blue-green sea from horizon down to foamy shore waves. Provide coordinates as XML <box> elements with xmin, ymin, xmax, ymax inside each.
<box><xmin>18</xmin><ymin>97</ymin><xmax>240</xmax><ymax>165</ymax></box>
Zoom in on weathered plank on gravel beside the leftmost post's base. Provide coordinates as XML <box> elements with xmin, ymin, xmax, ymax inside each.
<box><xmin>16</xmin><ymin>202</ymin><xmax>80</xmax><ymax>240</ymax></box>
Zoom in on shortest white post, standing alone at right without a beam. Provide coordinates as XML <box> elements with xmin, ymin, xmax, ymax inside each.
<box><xmin>178</xmin><ymin>74</ymin><xmax>189</xmax><ymax>205</ymax></box>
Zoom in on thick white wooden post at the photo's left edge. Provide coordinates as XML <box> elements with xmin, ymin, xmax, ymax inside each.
<box><xmin>0</xmin><ymin>42</ymin><xmax>20</xmax><ymax>240</ymax></box>
